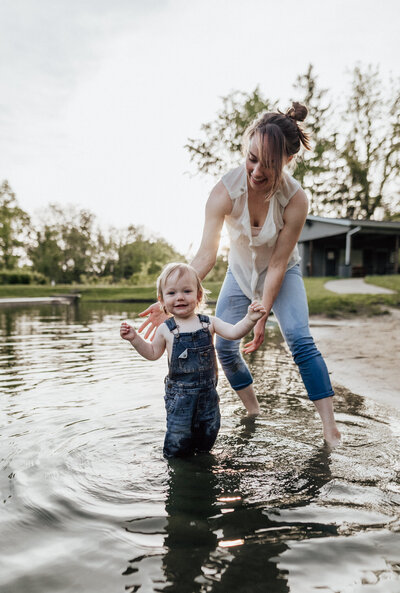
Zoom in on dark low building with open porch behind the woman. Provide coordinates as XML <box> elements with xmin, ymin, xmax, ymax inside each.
<box><xmin>299</xmin><ymin>216</ymin><xmax>400</xmax><ymax>277</ymax></box>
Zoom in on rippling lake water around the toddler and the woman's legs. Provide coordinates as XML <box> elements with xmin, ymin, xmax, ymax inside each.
<box><xmin>0</xmin><ymin>304</ymin><xmax>400</xmax><ymax>593</ymax></box>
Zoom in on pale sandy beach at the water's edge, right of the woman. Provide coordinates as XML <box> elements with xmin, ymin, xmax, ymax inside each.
<box><xmin>310</xmin><ymin>309</ymin><xmax>400</xmax><ymax>408</ymax></box>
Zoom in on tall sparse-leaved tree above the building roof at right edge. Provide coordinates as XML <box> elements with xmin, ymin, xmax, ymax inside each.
<box><xmin>330</xmin><ymin>65</ymin><xmax>400</xmax><ymax>219</ymax></box>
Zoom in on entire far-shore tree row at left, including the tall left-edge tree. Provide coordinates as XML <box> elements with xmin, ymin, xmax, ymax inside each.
<box><xmin>0</xmin><ymin>181</ymin><xmax>183</xmax><ymax>284</ymax></box>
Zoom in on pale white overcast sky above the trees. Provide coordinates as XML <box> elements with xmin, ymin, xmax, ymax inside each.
<box><xmin>0</xmin><ymin>0</ymin><xmax>400</xmax><ymax>254</ymax></box>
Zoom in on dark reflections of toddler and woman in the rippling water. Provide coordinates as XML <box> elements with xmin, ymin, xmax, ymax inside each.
<box><xmin>154</xmin><ymin>442</ymin><xmax>337</xmax><ymax>593</ymax></box>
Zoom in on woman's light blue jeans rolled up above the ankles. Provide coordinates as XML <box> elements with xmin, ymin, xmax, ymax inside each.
<box><xmin>215</xmin><ymin>265</ymin><xmax>334</xmax><ymax>401</ymax></box>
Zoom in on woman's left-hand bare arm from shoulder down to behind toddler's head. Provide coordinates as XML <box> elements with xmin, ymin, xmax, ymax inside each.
<box><xmin>191</xmin><ymin>181</ymin><xmax>232</xmax><ymax>280</ymax></box>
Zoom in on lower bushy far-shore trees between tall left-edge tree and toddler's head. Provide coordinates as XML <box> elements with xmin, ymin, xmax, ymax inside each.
<box><xmin>28</xmin><ymin>204</ymin><xmax>183</xmax><ymax>284</ymax></box>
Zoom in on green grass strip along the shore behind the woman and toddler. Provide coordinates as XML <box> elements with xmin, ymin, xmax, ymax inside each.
<box><xmin>0</xmin><ymin>275</ymin><xmax>400</xmax><ymax>317</ymax></box>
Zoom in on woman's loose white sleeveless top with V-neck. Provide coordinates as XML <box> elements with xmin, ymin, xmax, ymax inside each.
<box><xmin>222</xmin><ymin>164</ymin><xmax>300</xmax><ymax>300</ymax></box>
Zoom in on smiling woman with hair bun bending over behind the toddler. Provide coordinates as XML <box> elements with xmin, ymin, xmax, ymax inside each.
<box><xmin>139</xmin><ymin>103</ymin><xmax>340</xmax><ymax>445</ymax></box>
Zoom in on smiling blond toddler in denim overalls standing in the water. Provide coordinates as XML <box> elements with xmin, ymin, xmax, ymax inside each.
<box><xmin>121</xmin><ymin>263</ymin><xmax>266</xmax><ymax>457</ymax></box>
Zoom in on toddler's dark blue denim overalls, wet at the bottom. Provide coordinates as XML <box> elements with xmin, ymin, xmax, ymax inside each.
<box><xmin>163</xmin><ymin>315</ymin><xmax>220</xmax><ymax>457</ymax></box>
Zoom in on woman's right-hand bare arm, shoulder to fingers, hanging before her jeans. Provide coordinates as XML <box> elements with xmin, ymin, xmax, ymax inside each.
<box><xmin>243</xmin><ymin>189</ymin><xmax>308</xmax><ymax>353</ymax></box>
